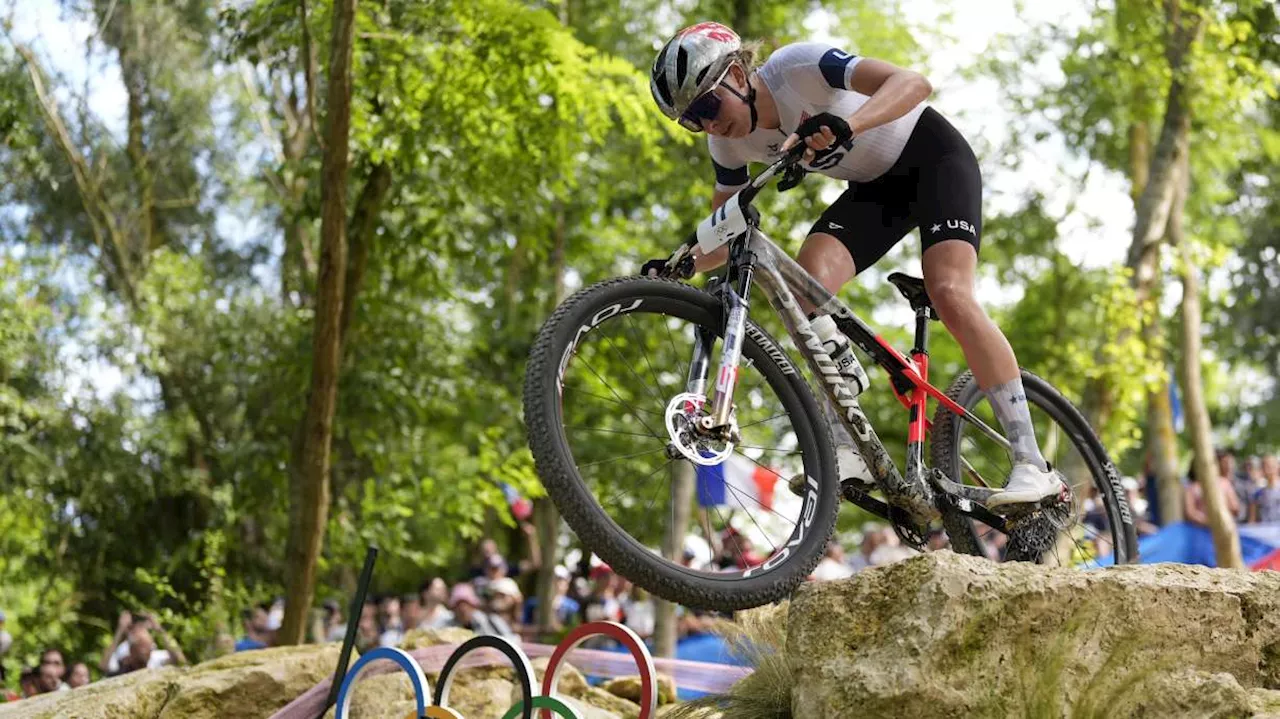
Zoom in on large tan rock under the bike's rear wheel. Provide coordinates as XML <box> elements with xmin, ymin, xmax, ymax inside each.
<box><xmin>786</xmin><ymin>551</ymin><xmax>1280</xmax><ymax>719</ymax></box>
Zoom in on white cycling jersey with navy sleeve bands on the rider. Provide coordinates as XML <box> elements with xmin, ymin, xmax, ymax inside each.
<box><xmin>707</xmin><ymin>42</ymin><xmax>925</xmax><ymax>192</ymax></box>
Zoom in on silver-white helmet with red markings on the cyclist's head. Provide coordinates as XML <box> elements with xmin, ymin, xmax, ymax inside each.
<box><xmin>649</xmin><ymin>23</ymin><xmax>754</xmax><ymax>132</ymax></box>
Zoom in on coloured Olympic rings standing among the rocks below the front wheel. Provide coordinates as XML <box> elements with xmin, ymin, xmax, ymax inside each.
<box><xmin>334</xmin><ymin>622</ymin><xmax>658</xmax><ymax>719</ymax></box>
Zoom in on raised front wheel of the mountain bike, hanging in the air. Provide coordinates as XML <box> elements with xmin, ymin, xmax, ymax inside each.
<box><xmin>525</xmin><ymin>278</ymin><xmax>840</xmax><ymax>610</ymax></box>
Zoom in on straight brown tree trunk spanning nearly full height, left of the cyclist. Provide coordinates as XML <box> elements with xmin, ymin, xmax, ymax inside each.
<box><xmin>276</xmin><ymin>0</ymin><xmax>356</xmax><ymax>645</ymax></box>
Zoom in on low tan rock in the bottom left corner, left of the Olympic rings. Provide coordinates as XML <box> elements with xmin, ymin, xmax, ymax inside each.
<box><xmin>0</xmin><ymin>637</ymin><xmax>338</xmax><ymax>719</ymax></box>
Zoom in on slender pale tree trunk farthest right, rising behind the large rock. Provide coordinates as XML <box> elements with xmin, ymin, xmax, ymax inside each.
<box><xmin>1169</xmin><ymin>170</ymin><xmax>1244</xmax><ymax>569</ymax></box>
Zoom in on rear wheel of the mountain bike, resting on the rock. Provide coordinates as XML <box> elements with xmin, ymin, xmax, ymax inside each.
<box><xmin>932</xmin><ymin>370</ymin><xmax>1138</xmax><ymax>567</ymax></box>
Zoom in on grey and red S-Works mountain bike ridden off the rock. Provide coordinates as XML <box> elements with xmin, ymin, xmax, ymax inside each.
<box><xmin>524</xmin><ymin>145</ymin><xmax>1138</xmax><ymax>610</ymax></box>
